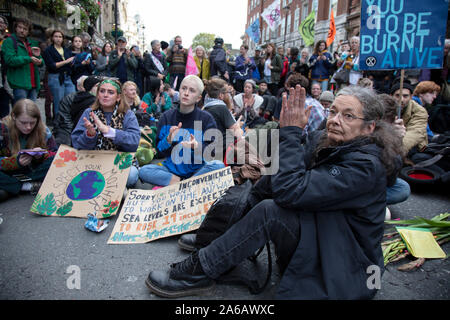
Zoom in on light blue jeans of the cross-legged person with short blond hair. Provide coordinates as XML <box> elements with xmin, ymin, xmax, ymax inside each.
<box><xmin>139</xmin><ymin>160</ymin><xmax>225</xmax><ymax>187</ymax></box>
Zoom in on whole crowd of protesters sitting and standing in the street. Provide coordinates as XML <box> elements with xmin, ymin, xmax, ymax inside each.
<box><xmin>0</xmin><ymin>17</ymin><xmax>450</xmax><ymax>298</ymax></box>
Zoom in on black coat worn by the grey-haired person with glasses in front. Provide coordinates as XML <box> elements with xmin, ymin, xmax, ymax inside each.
<box><xmin>271</xmin><ymin>127</ymin><xmax>387</xmax><ymax>299</ymax></box>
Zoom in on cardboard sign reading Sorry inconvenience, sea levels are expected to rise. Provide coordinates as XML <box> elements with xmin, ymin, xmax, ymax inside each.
<box><xmin>108</xmin><ymin>167</ymin><xmax>234</xmax><ymax>244</ymax></box>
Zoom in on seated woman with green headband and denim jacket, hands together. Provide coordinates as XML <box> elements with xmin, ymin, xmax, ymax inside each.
<box><xmin>72</xmin><ymin>79</ymin><xmax>140</xmax><ymax>187</ymax></box>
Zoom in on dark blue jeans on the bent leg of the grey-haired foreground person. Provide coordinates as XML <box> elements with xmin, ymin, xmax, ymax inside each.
<box><xmin>198</xmin><ymin>200</ymin><xmax>300</xmax><ymax>279</ymax></box>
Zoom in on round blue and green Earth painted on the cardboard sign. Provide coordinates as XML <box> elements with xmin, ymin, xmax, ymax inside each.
<box><xmin>66</xmin><ymin>170</ymin><xmax>105</xmax><ymax>201</ymax></box>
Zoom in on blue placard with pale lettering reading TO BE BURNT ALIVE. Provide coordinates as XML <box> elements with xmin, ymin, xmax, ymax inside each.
<box><xmin>359</xmin><ymin>0</ymin><xmax>448</xmax><ymax>70</ymax></box>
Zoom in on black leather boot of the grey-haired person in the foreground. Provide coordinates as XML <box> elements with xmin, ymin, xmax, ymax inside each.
<box><xmin>145</xmin><ymin>251</ymin><xmax>215</xmax><ymax>298</ymax></box>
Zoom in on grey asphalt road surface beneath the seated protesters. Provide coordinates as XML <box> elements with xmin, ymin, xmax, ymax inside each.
<box><xmin>0</xmin><ymin>184</ymin><xmax>450</xmax><ymax>300</ymax></box>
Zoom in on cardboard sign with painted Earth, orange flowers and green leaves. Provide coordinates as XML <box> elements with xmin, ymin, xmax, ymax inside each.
<box><xmin>30</xmin><ymin>145</ymin><xmax>133</xmax><ymax>218</ymax></box>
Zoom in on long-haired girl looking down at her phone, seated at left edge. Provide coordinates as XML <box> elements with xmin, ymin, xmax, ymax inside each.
<box><xmin>0</xmin><ymin>99</ymin><xmax>57</xmax><ymax>199</ymax></box>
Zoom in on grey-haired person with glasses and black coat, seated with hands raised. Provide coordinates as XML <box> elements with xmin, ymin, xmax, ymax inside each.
<box><xmin>146</xmin><ymin>85</ymin><xmax>401</xmax><ymax>299</ymax></box>
